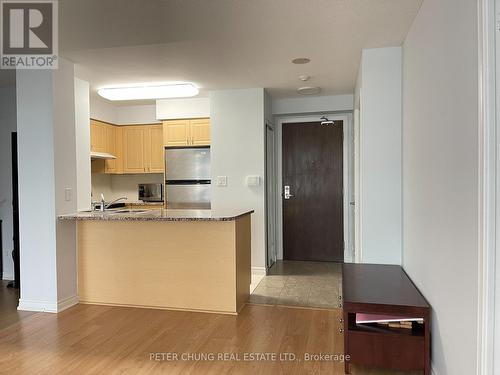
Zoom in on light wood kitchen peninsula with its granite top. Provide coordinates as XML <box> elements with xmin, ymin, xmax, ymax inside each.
<box><xmin>59</xmin><ymin>209</ymin><xmax>253</xmax><ymax>314</ymax></box>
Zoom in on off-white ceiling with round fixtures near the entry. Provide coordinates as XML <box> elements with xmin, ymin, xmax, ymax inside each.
<box><xmin>59</xmin><ymin>0</ymin><xmax>422</xmax><ymax>98</ymax></box>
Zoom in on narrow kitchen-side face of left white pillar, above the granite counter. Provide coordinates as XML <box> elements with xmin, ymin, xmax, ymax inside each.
<box><xmin>75</xmin><ymin>78</ymin><xmax>91</xmax><ymax>210</ymax></box>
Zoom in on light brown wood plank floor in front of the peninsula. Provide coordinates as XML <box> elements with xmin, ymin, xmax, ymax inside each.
<box><xmin>0</xmin><ymin>305</ymin><xmax>422</xmax><ymax>375</ymax></box>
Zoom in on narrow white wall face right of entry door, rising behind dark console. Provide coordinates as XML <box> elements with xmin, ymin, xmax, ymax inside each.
<box><xmin>356</xmin><ymin>47</ymin><xmax>402</xmax><ymax>264</ymax></box>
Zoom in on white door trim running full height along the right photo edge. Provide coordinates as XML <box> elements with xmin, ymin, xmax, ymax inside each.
<box><xmin>477</xmin><ymin>0</ymin><xmax>500</xmax><ymax>375</ymax></box>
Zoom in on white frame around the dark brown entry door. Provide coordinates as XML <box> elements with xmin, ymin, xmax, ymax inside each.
<box><xmin>275</xmin><ymin>112</ymin><xmax>357</xmax><ymax>262</ymax></box>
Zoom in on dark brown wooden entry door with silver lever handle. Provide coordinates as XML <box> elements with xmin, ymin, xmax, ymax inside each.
<box><xmin>282</xmin><ymin>121</ymin><xmax>344</xmax><ymax>262</ymax></box>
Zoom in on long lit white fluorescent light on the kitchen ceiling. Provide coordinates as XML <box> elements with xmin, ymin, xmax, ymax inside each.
<box><xmin>97</xmin><ymin>83</ymin><xmax>199</xmax><ymax>100</ymax></box>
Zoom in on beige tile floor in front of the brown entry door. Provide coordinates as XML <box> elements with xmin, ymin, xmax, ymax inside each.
<box><xmin>249</xmin><ymin>261</ymin><xmax>342</xmax><ymax>309</ymax></box>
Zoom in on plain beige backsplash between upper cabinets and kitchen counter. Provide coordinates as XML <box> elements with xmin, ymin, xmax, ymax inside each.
<box><xmin>92</xmin><ymin>173</ymin><xmax>163</xmax><ymax>202</ymax></box>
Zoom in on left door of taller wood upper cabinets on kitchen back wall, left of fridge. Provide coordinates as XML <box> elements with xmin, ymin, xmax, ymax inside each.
<box><xmin>123</xmin><ymin>126</ymin><xmax>146</xmax><ymax>173</ymax></box>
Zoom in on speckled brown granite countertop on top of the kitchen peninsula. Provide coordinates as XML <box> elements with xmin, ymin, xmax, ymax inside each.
<box><xmin>58</xmin><ymin>208</ymin><xmax>254</xmax><ymax>221</ymax></box>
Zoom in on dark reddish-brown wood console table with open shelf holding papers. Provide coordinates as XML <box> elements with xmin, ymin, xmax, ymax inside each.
<box><xmin>342</xmin><ymin>264</ymin><xmax>431</xmax><ymax>375</ymax></box>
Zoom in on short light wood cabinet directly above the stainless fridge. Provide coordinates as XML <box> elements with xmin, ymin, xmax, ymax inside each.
<box><xmin>163</xmin><ymin>118</ymin><xmax>211</xmax><ymax>146</ymax></box>
